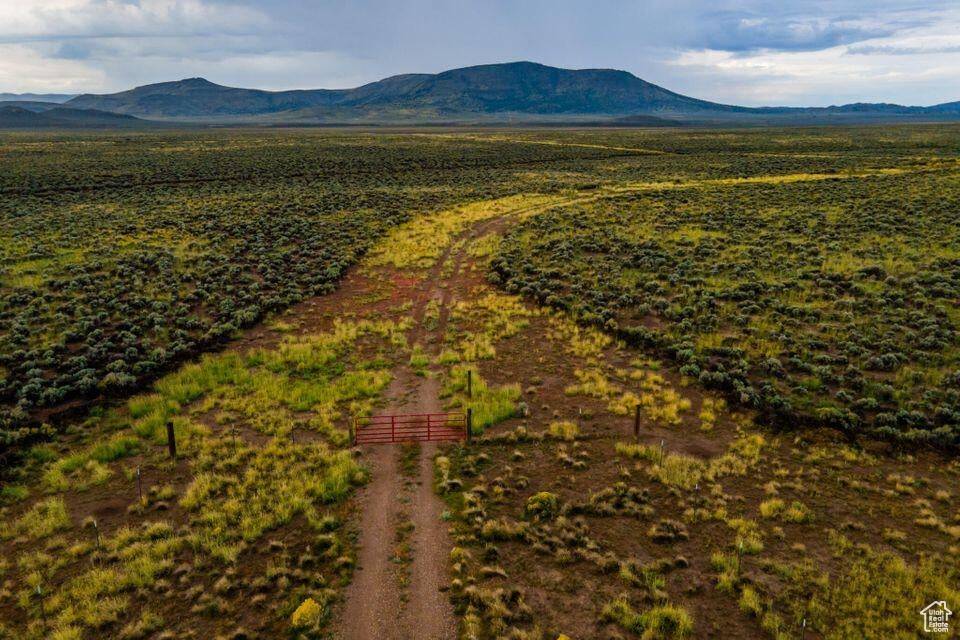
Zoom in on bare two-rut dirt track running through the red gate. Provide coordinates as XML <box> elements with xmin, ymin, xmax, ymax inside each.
<box><xmin>334</xmin><ymin>220</ymin><xmax>468</xmax><ymax>640</ymax></box>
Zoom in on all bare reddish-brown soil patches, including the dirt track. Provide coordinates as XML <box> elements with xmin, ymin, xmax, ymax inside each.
<box><xmin>0</xmin><ymin>200</ymin><xmax>958</xmax><ymax>640</ymax></box>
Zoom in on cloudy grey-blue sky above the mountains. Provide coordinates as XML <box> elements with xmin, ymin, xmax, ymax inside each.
<box><xmin>0</xmin><ymin>0</ymin><xmax>960</xmax><ymax>106</ymax></box>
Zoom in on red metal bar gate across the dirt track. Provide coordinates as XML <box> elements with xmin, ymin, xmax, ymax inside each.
<box><xmin>352</xmin><ymin>413</ymin><xmax>468</xmax><ymax>444</ymax></box>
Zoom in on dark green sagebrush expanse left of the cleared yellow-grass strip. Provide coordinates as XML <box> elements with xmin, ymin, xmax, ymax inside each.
<box><xmin>0</xmin><ymin>131</ymin><xmax>632</xmax><ymax>452</ymax></box>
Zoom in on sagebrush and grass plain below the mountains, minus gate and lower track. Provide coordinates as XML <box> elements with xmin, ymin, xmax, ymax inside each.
<box><xmin>0</xmin><ymin>126</ymin><xmax>960</xmax><ymax>640</ymax></box>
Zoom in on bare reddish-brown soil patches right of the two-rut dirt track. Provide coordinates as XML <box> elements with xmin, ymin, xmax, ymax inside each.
<box><xmin>416</xmin><ymin>220</ymin><xmax>958</xmax><ymax>640</ymax></box>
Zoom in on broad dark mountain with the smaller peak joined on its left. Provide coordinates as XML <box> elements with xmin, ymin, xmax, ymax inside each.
<box><xmin>67</xmin><ymin>62</ymin><xmax>742</xmax><ymax>121</ymax></box>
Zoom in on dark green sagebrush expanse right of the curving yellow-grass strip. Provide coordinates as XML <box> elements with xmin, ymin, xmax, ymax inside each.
<box><xmin>494</xmin><ymin>132</ymin><xmax>960</xmax><ymax>447</ymax></box>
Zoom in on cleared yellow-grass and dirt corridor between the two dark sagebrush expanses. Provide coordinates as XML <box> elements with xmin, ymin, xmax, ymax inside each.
<box><xmin>0</xmin><ymin>127</ymin><xmax>960</xmax><ymax>640</ymax></box>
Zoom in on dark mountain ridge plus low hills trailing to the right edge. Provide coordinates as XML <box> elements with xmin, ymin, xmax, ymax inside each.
<box><xmin>52</xmin><ymin>62</ymin><xmax>960</xmax><ymax>126</ymax></box>
